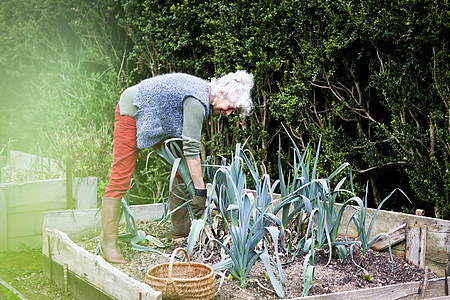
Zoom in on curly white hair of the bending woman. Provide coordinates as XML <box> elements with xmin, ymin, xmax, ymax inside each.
<box><xmin>211</xmin><ymin>71</ymin><xmax>253</xmax><ymax>117</ymax></box>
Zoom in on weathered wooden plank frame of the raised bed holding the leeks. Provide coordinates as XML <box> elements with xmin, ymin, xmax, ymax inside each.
<box><xmin>43</xmin><ymin>205</ymin><xmax>450</xmax><ymax>299</ymax></box>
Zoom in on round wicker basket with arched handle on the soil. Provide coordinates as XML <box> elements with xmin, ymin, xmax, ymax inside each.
<box><xmin>145</xmin><ymin>248</ymin><xmax>215</xmax><ymax>299</ymax></box>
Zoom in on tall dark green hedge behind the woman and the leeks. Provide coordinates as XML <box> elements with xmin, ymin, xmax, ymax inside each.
<box><xmin>118</xmin><ymin>0</ymin><xmax>450</xmax><ymax>218</ymax></box>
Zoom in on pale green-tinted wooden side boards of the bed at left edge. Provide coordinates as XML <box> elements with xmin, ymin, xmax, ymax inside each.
<box><xmin>0</xmin><ymin>177</ymin><xmax>97</xmax><ymax>252</ymax></box>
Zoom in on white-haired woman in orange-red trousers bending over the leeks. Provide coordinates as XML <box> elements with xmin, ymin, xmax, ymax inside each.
<box><xmin>100</xmin><ymin>71</ymin><xmax>253</xmax><ymax>264</ymax></box>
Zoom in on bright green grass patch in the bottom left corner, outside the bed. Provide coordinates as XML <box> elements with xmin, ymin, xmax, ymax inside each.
<box><xmin>0</xmin><ymin>248</ymin><xmax>74</xmax><ymax>300</ymax></box>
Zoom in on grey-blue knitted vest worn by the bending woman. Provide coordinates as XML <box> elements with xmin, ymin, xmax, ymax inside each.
<box><xmin>134</xmin><ymin>73</ymin><xmax>210</xmax><ymax>149</ymax></box>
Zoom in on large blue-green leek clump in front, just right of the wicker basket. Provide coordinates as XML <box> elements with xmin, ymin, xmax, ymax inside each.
<box><xmin>211</xmin><ymin>144</ymin><xmax>284</xmax><ymax>297</ymax></box>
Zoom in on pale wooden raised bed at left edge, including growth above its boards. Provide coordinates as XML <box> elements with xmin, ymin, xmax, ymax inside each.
<box><xmin>0</xmin><ymin>151</ymin><xmax>97</xmax><ymax>252</ymax></box>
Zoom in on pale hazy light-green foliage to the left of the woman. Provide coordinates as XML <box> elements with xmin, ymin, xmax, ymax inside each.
<box><xmin>0</xmin><ymin>0</ymin><xmax>131</xmax><ymax>185</ymax></box>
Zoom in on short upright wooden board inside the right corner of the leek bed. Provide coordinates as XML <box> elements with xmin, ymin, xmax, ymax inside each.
<box><xmin>405</xmin><ymin>224</ymin><xmax>427</xmax><ymax>269</ymax></box>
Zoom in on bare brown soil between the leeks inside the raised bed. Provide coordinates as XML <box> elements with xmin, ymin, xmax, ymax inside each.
<box><xmin>82</xmin><ymin>219</ymin><xmax>437</xmax><ymax>300</ymax></box>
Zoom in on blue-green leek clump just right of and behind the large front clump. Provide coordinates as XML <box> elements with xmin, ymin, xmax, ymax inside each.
<box><xmin>273</xmin><ymin>131</ymin><xmax>352</xmax><ymax>260</ymax></box>
